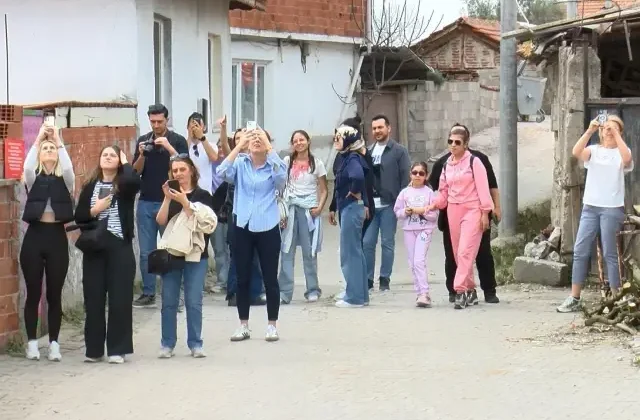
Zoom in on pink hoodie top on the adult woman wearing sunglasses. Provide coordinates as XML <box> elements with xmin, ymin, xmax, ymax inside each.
<box><xmin>434</xmin><ymin>150</ymin><xmax>493</xmax><ymax>213</ymax></box>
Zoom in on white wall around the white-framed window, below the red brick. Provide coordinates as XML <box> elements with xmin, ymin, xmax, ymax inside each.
<box><xmin>230</xmin><ymin>37</ymin><xmax>358</xmax><ymax>166</ymax></box>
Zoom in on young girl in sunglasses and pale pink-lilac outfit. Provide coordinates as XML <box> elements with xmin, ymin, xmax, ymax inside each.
<box><xmin>393</xmin><ymin>162</ymin><xmax>438</xmax><ymax>308</ymax></box>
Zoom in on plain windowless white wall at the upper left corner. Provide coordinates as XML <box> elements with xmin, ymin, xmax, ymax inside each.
<box><xmin>0</xmin><ymin>0</ymin><xmax>136</xmax><ymax>104</ymax></box>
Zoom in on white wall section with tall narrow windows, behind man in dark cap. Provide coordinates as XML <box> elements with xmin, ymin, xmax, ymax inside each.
<box><xmin>137</xmin><ymin>0</ymin><xmax>231</xmax><ymax>135</ymax></box>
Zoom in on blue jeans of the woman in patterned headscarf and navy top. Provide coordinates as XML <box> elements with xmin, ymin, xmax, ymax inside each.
<box><xmin>340</xmin><ymin>201</ymin><xmax>369</xmax><ymax>305</ymax></box>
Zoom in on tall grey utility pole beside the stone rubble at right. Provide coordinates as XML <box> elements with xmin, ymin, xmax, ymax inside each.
<box><xmin>498</xmin><ymin>0</ymin><xmax>518</xmax><ymax>237</ymax></box>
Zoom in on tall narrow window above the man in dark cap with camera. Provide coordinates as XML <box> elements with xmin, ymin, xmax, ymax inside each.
<box><xmin>153</xmin><ymin>14</ymin><xmax>171</xmax><ymax>109</ymax></box>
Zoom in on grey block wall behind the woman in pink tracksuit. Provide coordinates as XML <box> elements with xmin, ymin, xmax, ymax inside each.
<box><xmin>408</xmin><ymin>81</ymin><xmax>500</xmax><ymax>160</ymax></box>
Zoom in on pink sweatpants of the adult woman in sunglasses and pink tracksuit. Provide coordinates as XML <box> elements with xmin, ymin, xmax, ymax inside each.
<box><xmin>447</xmin><ymin>202</ymin><xmax>482</xmax><ymax>293</ymax></box>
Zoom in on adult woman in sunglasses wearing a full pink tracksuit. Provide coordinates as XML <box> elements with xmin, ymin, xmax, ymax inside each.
<box><xmin>426</xmin><ymin>126</ymin><xmax>493</xmax><ymax>309</ymax></box>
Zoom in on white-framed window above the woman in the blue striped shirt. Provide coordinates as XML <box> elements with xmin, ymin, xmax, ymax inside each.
<box><xmin>231</xmin><ymin>61</ymin><xmax>266</xmax><ymax>130</ymax></box>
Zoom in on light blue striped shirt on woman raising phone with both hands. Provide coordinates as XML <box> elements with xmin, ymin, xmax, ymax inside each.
<box><xmin>216</xmin><ymin>150</ymin><xmax>287</xmax><ymax>232</ymax></box>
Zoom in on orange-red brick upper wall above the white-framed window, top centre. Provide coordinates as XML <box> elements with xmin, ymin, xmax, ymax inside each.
<box><xmin>229</xmin><ymin>0</ymin><xmax>367</xmax><ymax>37</ymax></box>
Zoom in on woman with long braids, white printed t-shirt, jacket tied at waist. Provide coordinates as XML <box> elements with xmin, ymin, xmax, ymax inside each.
<box><xmin>278</xmin><ymin>130</ymin><xmax>328</xmax><ymax>304</ymax></box>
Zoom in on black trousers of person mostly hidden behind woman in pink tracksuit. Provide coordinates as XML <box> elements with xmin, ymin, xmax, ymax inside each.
<box><xmin>442</xmin><ymin>223</ymin><xmax>496</xmax><ymax>294</ymax></box>
